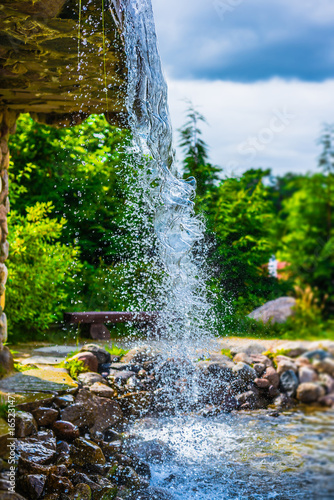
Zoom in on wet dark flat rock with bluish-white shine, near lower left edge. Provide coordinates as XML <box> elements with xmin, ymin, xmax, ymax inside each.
<box><xmin>16</xmin><ymin>436</ymin><xmax>56</xmax><ymax>465</ymax></box>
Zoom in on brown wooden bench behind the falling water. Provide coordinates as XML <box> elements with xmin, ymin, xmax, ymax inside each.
<box><xmin>64</xmin><ymin>311</ymin><xmax>158</xmax><ymax>340</ymax></box>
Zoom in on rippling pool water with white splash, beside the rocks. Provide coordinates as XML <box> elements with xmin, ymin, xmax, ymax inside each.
<box><xmin>129</xmin><ymin>411</ymin><xmax>334</xmax><ymax>500</ymax></box>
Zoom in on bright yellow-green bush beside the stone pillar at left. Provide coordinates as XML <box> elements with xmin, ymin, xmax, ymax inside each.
<box><xmin>6</xmin><ymin>202</ymin><xmax>80</xmax><ymax>340</ymax></box>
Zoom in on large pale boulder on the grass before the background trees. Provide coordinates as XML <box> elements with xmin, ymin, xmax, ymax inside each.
<box><xmin>248</xmin><ymin>297</ymin><xmax>296</xmax><ymax>324</ymax></box>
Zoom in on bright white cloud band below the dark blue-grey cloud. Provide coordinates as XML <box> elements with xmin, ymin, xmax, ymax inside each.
<box><xmin>168</xmin><ymin>79</ymin><xmax>334</xmax><ymax>175</ymax></box>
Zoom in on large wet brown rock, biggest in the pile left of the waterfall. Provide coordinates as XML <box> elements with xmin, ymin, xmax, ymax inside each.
<box><xmin>61</xmin><ymin>389</ymin><xmax>123</xmax><ymax>434</ymax></box>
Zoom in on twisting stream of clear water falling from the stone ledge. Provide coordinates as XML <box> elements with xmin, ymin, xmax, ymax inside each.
<box><xmin>111</xmin><ymin>0</ymin><xmax>214</xmax><ymax>350</ymax></box>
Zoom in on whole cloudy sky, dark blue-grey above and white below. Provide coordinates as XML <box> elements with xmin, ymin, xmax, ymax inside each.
<box><xmin>152</xmin><ymin>0</ymin><xmax>334</xmax><ymax>175</ymax></box>
